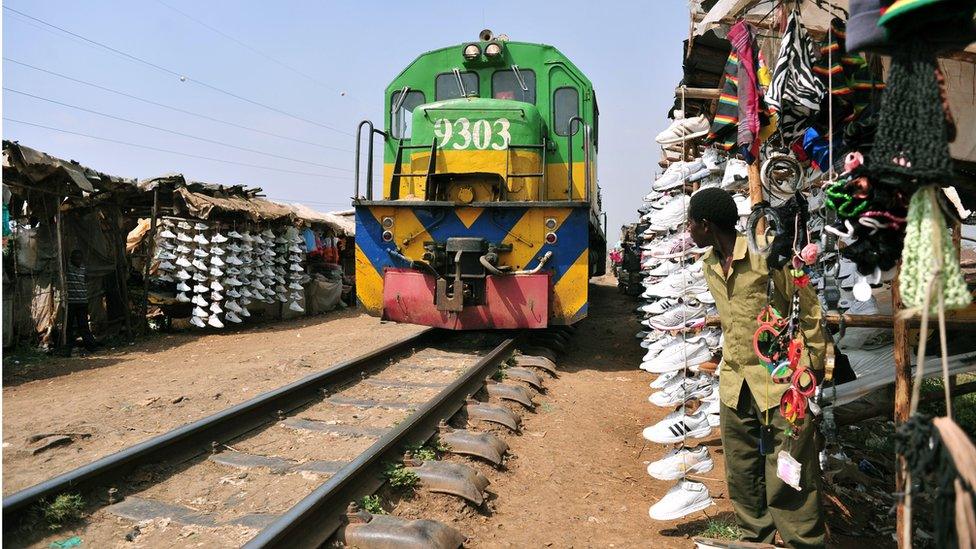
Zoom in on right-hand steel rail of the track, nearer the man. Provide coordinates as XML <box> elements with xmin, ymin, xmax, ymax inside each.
<box><xmin>244</xmin><ymin>339</ymin><xmax>515</xmax><ymax>549</ymax></box>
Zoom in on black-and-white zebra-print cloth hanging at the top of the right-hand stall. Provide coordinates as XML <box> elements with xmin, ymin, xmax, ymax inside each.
<box><xmin>766</xmin><ymin>10</ymin><xmax>827</xmax><ymax>143</ymax></box>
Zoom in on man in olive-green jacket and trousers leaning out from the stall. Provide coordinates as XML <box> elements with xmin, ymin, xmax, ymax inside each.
<box><xmin>688</xmin><ymin>187</ymin><xmax>826</xmax><ymax>547</ymax></box>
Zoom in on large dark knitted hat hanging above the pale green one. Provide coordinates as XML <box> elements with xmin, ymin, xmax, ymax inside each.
<box><xmin>869</xmin><ymin>40</ymin><xmax>952</xmax><ymax>188</ymax></box>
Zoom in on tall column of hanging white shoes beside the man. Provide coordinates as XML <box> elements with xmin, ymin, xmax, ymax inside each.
<box><xmin>621</xmin><ymin>113</ymin><xmax>724</xmax><ymax>521</ymax></box>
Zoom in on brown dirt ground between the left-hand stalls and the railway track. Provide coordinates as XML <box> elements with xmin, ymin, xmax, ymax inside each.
<box><xmin>3</xmin><ymin>310</ymin><xmax>420</xmax><ymax>495</ymax></box>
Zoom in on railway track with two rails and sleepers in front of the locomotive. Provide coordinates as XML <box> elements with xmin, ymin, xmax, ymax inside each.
<box><xmin>3</xmin><ymin>329</ymin><xmax>565</xmax><ymax>548</ymax></box>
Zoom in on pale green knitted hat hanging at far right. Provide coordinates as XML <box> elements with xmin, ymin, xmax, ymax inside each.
<box><xmin>898</xmin><ymin>185</ymin><xmax>972</xmax><ymax>313</ymax></box>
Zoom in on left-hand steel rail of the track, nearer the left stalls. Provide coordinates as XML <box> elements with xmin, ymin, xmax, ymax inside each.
<box><xmin>3</xmin><ymin>328</ymin><xmax>445</xmax><ymax>530</ymax></box>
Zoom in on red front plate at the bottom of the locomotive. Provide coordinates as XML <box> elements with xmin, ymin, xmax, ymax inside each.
<box><xmin>383</xmin><ymin>269</ymin><xmax>550</xmax><ymax>330</ymax></box>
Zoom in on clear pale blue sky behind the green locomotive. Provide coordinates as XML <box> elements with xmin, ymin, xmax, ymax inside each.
<box><xmin>2</xmin><ymin>0</ymin><xmax>688</xmax><ymax>240</ymax></box>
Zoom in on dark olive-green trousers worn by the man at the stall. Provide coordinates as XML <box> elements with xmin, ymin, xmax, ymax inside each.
<box><xmin>720</xmin><ymin>382</ymin><xmax>825</xmax><ymax>547</ymax></box>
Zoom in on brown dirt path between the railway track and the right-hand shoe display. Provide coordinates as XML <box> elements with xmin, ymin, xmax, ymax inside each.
<box><xmin>392</xmin><ymin>277</ymin><xmax>732</xmax><ymax>548</ymax></box>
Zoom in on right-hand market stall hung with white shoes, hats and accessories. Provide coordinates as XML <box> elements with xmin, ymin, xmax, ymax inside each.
<box><xmin>637</xmin><ymin>0</ymin><xmax>976</xmax><ymax>546</ymax></box>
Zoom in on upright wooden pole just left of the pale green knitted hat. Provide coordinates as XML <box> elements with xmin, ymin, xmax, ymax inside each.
<box><xmin>891</xmin><ymin>265</ymin><xmax>925</xmax><ymax>549</ymax></box>
